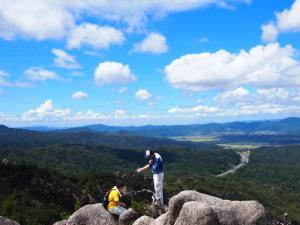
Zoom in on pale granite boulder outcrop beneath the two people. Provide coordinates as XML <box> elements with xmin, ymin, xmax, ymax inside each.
<box><xmin>55</xmin><ymin>191</ymin><xmax>268</xmax><ymax>225</ymax></box>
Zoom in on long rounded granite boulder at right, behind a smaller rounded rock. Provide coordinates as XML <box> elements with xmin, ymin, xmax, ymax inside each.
<box><xmin>165</xmin><ymin>191</ymin><xmax>267</xmax><ymax>225</ymax></box>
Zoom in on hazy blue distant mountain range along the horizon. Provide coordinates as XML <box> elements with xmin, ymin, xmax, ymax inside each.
<box><xmin>25</xmin><ymin>117</ymin><xmax>300</xmax><ymax>137</ymax></box>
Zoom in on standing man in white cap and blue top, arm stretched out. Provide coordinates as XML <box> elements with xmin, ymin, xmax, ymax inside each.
<box><xmin>136</xmin><ymin>150</ymin><xmax>164</xmax><ymax>206</ymax></box>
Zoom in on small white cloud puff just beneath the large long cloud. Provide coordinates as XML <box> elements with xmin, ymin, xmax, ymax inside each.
<box><xmin>214</xmin><ymin>87</ymin><xmax>250</xmax><ymax>103</ymax></box>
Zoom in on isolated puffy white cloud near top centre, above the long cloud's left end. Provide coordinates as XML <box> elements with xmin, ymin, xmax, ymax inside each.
<box><xmin>132</xmin><ymin>33</ymin><xmax>169</xmax><ymax>54</ymax></box>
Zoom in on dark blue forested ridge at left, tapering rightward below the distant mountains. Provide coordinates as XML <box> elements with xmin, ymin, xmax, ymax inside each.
<box><xmin>0</xmin><ymin>125</ymin><xmax>218</xmax><ymax>149</ymax></box>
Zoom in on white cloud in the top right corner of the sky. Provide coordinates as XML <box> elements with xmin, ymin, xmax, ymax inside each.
<box><xmin>262</xmin><ymin>0</ymin><xmax>300</xmax><ymax>41</ymax></box>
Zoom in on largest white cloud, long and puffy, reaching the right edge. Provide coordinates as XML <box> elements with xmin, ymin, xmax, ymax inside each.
<box><xmin>164</xmin><ymin>43</ymin><xmax>300</xmax><ymax>91</ymax></box>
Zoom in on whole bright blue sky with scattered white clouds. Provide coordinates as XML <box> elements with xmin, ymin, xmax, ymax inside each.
<box><xmin>0</xmin><ymin>0</ymin><xmax>300</xmax><ymax>127</ymax></box>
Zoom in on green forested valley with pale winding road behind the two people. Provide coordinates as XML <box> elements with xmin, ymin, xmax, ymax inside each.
<box><xmin>0</xmin><ymin>118</ymin><xmax>300</xmax><ymax>225</ymax></box>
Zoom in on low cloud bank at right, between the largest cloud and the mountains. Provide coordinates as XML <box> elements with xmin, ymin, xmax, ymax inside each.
<box><xmin>168</xmin><ymin>87</ymin><xmax>300</xmax><ymax>119</ymax></box>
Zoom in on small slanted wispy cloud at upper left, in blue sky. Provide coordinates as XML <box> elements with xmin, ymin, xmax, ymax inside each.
<box><xmin>52</xmin><ymin>48</ymin><xmax>80</xmax><ymax>69</ymax></box>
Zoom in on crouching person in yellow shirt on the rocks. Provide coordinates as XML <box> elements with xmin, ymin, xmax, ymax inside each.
<box><xmin>107</xmin><ymin>184</ymin><xmax>127</xmax><ymax>216</ymax></box>
